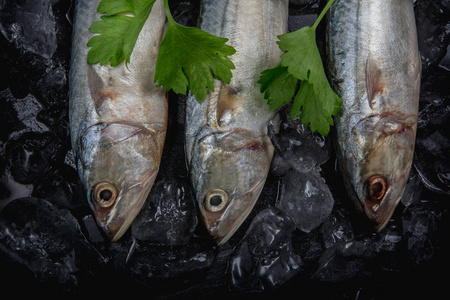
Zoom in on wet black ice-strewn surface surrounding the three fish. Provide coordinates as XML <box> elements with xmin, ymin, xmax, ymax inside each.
<box><xmin>0</xmin><ymin>0</ymin><xmax>450</xmax><ymax>299</ymax></box>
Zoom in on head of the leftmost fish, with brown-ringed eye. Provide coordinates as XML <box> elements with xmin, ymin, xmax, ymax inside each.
<box><xmin>76</xmin><ymin>123</ymin><xmax>164</xmax><ymax>242</ymax></box>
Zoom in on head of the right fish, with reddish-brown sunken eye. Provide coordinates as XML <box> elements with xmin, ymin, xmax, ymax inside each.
<box><xmin>352</xmin><ymin>113</ymin><xmax>417</xmax><ymax>231</ymax></box>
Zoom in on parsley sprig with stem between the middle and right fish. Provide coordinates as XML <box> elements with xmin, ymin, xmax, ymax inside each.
<box><xmin>258</xmin><ymin>0</ymin><xmax>342</xmax><ymax>136</ymax></box>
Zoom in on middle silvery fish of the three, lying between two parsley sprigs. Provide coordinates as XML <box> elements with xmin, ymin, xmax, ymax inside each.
<box><xmin>186</xmin><ymin>0</ymin><xmax>288</xmax><ymax>245</ymax></box>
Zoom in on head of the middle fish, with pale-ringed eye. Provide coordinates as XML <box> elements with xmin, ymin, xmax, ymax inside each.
<box><xmin>191</xmin><ymin>130</ymin><xmax>273</xmax><ymax>246</ymax></box>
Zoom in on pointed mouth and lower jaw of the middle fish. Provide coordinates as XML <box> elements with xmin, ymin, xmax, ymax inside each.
<box><xmin>201</xmin><ymin>179</ymin><xmax>265</xmax><ymax>246</ymax></box>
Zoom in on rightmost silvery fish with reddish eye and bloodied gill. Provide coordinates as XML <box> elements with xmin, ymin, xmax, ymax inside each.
<box><xmin>327</xmin><ymin>0</ymin><xmax>421</xmax><ymax>230</ymax></box>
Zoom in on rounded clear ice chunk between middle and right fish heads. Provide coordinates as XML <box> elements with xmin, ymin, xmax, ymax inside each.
<box><xmin>276</xmin><ymin>169</ymin><xmax>334</xmax><ymax>232</ymax></box>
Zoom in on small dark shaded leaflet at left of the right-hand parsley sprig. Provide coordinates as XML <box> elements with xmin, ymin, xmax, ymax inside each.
<box><xmin>258</xmin><ymin>64</ymin><xmax>298</xmax><ymax>110</ymax></box>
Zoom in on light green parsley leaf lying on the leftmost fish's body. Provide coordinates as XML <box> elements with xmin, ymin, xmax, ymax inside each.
<box><xmin>87</xmin><ymin>0</ymin><xmax>156</xmax><ymax>67</ymax></box>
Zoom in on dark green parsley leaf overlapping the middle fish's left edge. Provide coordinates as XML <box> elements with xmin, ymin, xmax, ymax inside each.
<box><xmin>155</xmin><ymin>0</ymin><xmax>236</xmax><ymax>103</ymax></box>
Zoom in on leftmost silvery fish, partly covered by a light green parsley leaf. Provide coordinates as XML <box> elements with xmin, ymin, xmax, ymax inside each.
<box><xmin>69</xmin><ymin>0</ymin><xmax>168</xmax><ymax>241</ymax></box>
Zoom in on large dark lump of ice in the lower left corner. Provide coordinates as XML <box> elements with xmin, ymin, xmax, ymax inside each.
<box><xmin>0</xmin><ymin>198</ymin><xmax>104</xmax><ymax>288</ymax></box>
